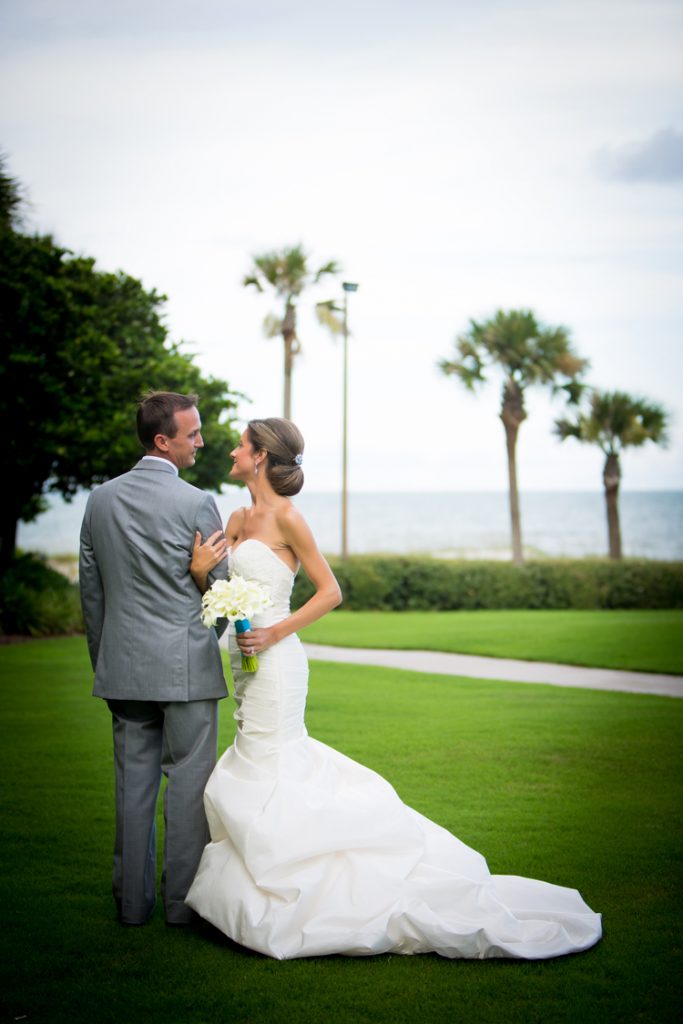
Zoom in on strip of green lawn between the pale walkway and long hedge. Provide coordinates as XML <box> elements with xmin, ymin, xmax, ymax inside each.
<box><xmin>301</xmin><ymin>610</ymin><xmax>683</xmax><ymax>675</ymax></box>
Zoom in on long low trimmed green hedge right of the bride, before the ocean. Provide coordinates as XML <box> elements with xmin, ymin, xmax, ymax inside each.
<box><xmin>293</xmin><ymin>555</ymin><xmax>683</xmax><ymax>611</ymax></box>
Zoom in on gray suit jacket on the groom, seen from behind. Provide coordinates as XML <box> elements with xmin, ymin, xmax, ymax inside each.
<box><xmin>80</xmin><ymin>460</ymin><xmax>227</xmax><ymax>700</ymax></box>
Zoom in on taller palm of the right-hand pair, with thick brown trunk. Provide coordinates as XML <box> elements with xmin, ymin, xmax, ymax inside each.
<box><xmin>438</xmin><ymin>309</ymin><xmax>588</xmax><ymax>565</ymax></box>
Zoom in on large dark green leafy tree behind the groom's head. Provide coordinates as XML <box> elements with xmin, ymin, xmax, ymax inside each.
<box><xmin>0</xmin><ymin>159</ymin><xmax>241</xmax><ymax>570</ymax></box>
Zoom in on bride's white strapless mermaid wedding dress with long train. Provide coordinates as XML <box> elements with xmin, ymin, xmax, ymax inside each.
<box><xmin>187</xmin><ymin>540</ymin><xmax>601</xmax><ymax>959</ymax></box>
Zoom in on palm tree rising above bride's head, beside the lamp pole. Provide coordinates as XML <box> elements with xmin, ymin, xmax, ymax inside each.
<box><xmin>243</xmin><ymin>245</ymin><xmax>339</xmax><ymax>420</ymax></box>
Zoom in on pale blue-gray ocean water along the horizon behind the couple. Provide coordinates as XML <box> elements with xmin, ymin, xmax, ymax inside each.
<box><xmin>18</xmin><ymin>487</ymin><xmax>683</xmax><ymax>559</ymax></box>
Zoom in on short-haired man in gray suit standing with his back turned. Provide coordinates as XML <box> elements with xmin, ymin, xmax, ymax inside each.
<box><xmin>80</xmin><ymin>391</ymin><xmax>227</xmax><ymax>925</ymax></box>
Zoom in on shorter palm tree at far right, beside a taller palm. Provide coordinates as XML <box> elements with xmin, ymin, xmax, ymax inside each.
<box><xmin>555</xmin><ymin>390</ymin><xmax>668</xmax><ymax>558</ymax></box>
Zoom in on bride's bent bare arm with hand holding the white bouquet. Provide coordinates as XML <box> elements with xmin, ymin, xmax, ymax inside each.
<box><xmin>238</xmin><ymin>506</ymin><xmax>342</xmax><ymax>653</ymax></box>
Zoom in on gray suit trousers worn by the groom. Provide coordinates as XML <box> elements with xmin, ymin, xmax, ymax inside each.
<box><xmin>108</xmin><ymin>699</ymin><xmax>218</xmax><ymax>925</ymax></box>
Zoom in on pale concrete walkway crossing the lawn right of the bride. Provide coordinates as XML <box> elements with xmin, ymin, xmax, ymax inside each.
<box><xmin>304</xmin><ymin>643</ymin><xmax>683</xmax><ymax>697</ymax></box>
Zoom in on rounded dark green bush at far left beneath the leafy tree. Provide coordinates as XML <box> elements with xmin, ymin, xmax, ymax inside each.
<box><xmin>0</xmin><ymin>554</ymin><xmax>83</xmax><ymax>637</ymax></box>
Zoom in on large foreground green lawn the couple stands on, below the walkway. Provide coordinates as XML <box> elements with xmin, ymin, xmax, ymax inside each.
<box><xmin>0</xmin><ymin>638</ymin><xmax>683</xmax><ymax>1024</ymax></box>
